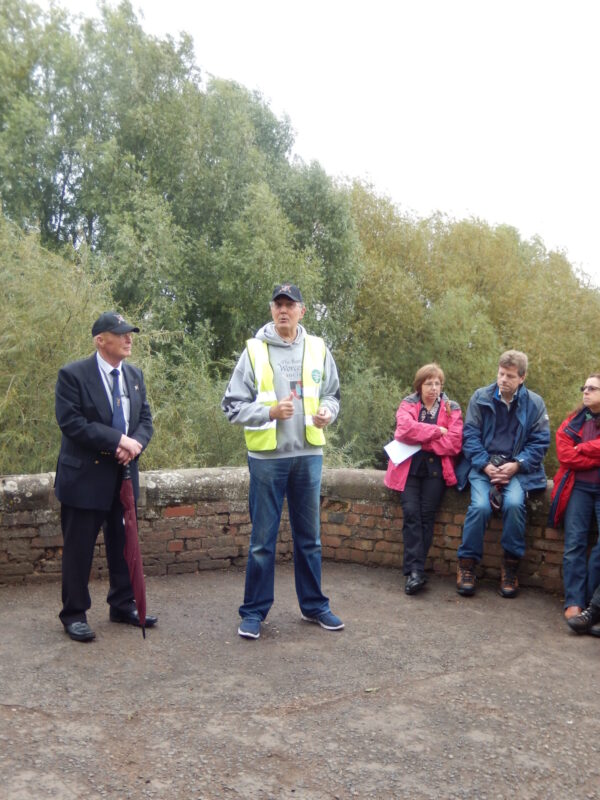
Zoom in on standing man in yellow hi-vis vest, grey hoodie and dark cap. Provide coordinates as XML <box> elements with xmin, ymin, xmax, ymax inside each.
<box><xmin>221</xmin><ymin>283</ymin><xmax>344</xmax><ymax>639</ymax></box>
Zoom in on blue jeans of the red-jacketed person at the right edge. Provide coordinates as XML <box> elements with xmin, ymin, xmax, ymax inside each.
<box><xmin>563</xmin><ymin>485</ymin><xmax>600</xmax><ymax>608</ymax></box>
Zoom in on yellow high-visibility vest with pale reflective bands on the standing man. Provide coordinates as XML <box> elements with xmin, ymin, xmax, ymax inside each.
<box><xmin>244</xmin><ymin>335</ymin><xmax>325</xmax><ymax>451</ymax></box>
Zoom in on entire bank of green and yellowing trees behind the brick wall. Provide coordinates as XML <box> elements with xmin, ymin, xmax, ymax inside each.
<box><xmin>0</xmin><ymin>0</ymin><xmax>600</xmax><ymax>482</ymax></box>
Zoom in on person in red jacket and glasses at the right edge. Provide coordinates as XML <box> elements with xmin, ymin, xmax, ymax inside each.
<box><xmin>549</xmin><ymin>373</ymin><xmax>600</xmax><ymax>622</ymax></box>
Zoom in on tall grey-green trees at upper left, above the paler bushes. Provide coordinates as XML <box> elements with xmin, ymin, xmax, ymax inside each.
<box><xmin>0</xmin><ymin>0</ymin><xmax>358</xmax><ymax>359</ymax></box>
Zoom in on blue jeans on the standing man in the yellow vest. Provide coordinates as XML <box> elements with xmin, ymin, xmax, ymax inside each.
<box><xmin>240</xmin><ymin>455</ymin><xmax>329</xmax><ymax>620</ymax></box>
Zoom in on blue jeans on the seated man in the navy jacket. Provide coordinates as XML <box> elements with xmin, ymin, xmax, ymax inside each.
<box><xmin>458</xmin><ymin>468</ymin><xmax>526</xmax><ymax>561</ymax></box>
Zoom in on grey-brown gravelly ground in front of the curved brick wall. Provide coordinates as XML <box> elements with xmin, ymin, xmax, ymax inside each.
<box><xmin>0</xmin><ymin>563</ymin><xmax>600</xmax><ymax>800</ymax></box>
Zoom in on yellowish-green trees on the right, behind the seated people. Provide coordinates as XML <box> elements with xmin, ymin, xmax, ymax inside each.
<box><xmin>344</xmin><ymin>190</ymin><xmax>600</xmax><ymax>474</ymax></box>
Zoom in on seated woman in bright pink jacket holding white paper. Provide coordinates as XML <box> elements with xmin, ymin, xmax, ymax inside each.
<box><xmin>385</xmin><ymin>364</ymin><xmax>463</xmax><ymax>594</ymax></box>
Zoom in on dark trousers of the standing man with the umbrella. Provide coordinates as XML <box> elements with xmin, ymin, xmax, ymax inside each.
<box><xmin>59</xmin><ymin>493</ymin><xmax>134</xmax><ymax>625</ymax></box>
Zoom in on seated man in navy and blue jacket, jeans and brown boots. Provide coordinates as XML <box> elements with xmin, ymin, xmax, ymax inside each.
<box><xmin>456</xmin><ymin>350</ymin><xmax>550</xmax><ymax>597</ymax></box>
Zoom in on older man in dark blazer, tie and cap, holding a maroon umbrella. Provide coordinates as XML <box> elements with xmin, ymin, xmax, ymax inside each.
<box><xmin>55</xmin><ymin>311</ymin><xmax>156</xmax><ymax>642</ymax></box>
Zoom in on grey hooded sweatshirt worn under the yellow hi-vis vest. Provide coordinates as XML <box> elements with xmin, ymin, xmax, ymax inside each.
<box><xmin>221</xmin><ymin>322</ymin><xmax>340</xmax><ymax>458</ymax></box>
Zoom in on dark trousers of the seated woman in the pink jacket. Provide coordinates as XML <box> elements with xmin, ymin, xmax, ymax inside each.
<box><xmin>400</xmin><ymin>475</ymin><xmax>446</xmax><ymax>575</ymax></box>
